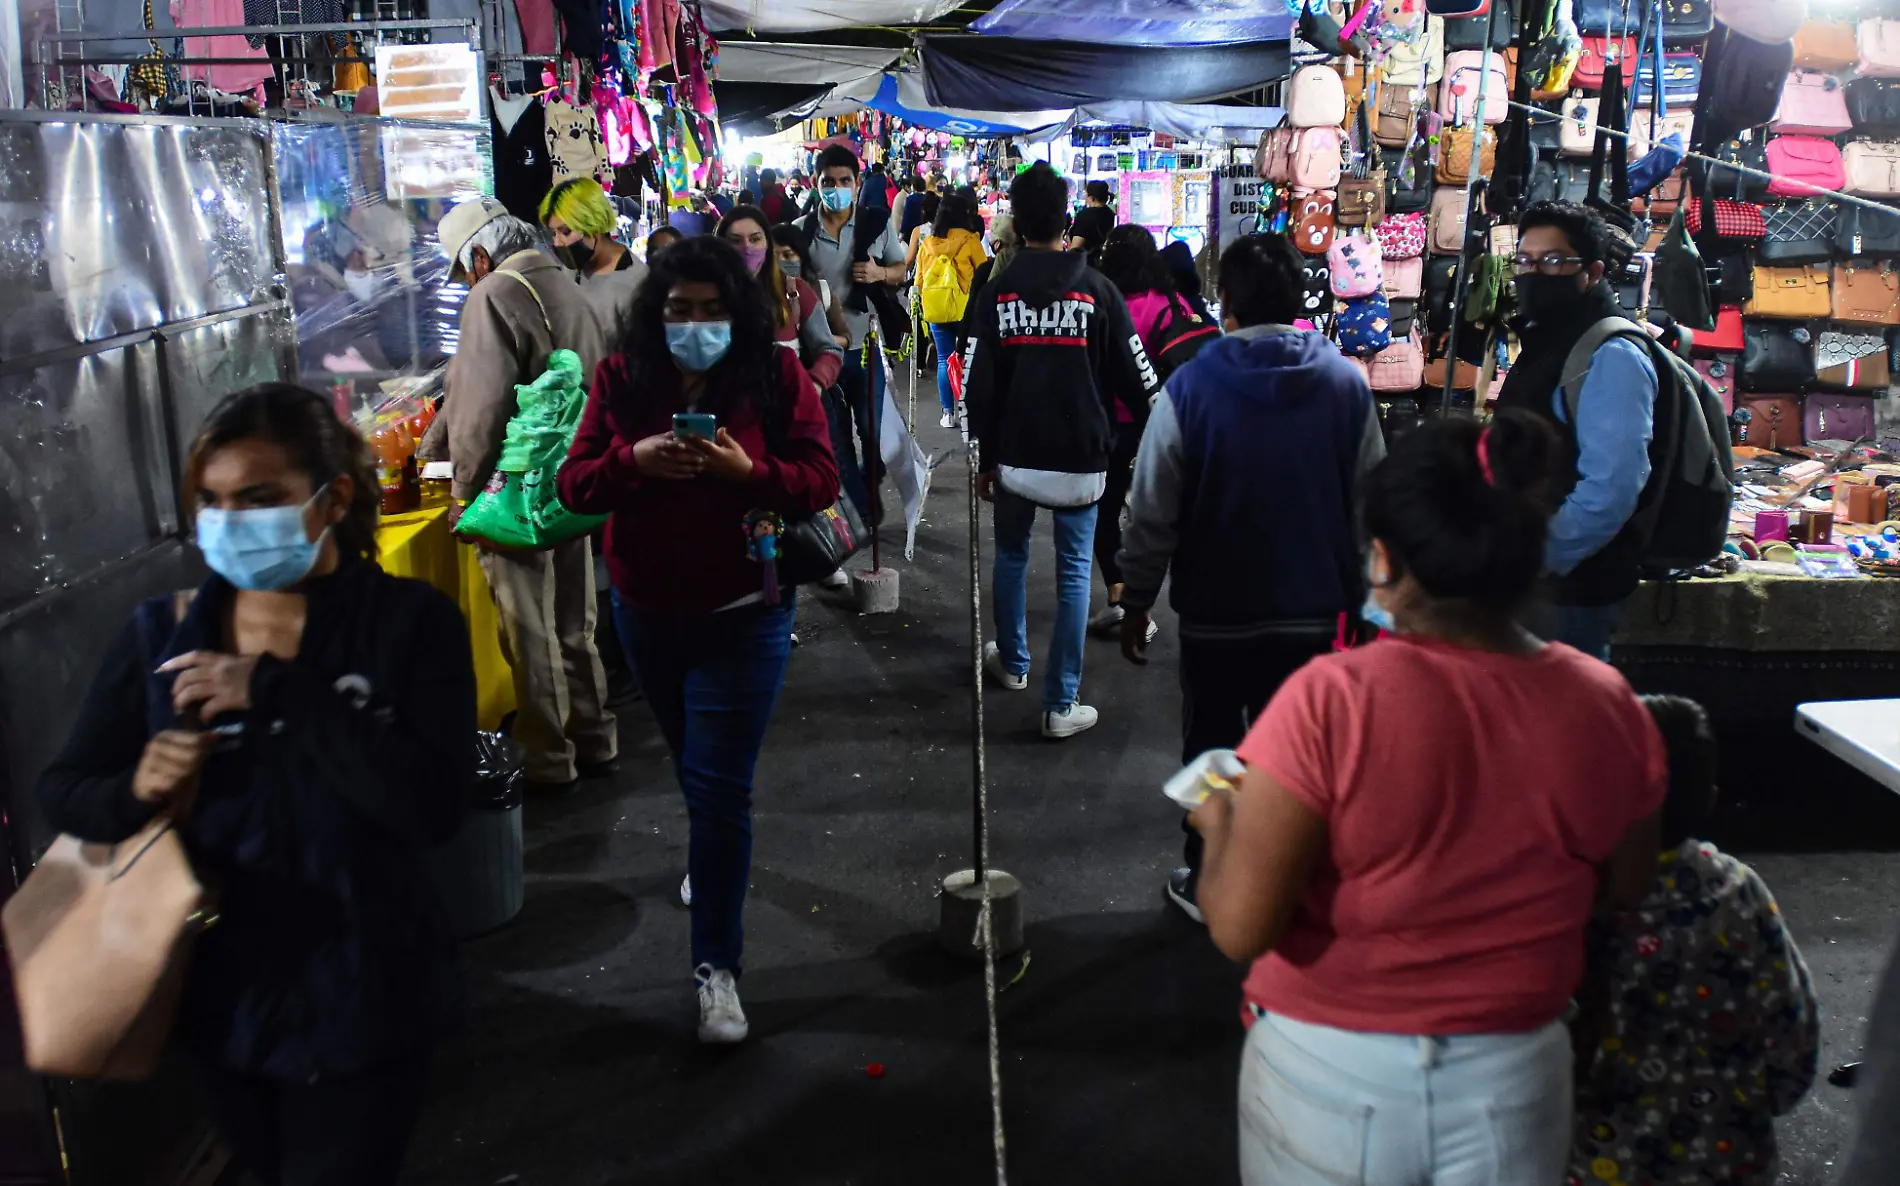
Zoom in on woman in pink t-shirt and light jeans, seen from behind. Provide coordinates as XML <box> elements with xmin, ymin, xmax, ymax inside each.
<box><xmin>1191</xmin><ymin>414</ymin><xmax>1664</xmax><ymax>1186</ymax></box>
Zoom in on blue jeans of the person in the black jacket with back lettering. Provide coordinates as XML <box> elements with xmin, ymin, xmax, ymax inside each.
<box><xmin>990</xmin><ymin>488</ymin><xmax>1096</xmax><ymax>713</ymax></box>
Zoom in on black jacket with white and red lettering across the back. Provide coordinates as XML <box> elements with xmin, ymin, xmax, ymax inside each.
<box><xmin>963</xmin><ymin>247</ymin><xmax>1161</xmax><ymax>485</ymax></box>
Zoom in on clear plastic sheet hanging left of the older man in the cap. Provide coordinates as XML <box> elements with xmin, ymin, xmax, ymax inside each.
<box><xmin>272</xmin><ymin>120</ymin><xmax>490</xmax><ymax>402</ymax></box>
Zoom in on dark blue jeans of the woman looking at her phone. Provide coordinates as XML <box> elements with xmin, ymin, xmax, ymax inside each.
<box><xmin>614</xmin><ymin>593</ymin><xmax>794</xmax><ymax>975</ymax></box>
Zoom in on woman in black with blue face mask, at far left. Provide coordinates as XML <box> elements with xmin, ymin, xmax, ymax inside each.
<box><xmin>40</xmin><ymin>384</ymin><xmax>475</xmax><ymax>1184</ymax></box>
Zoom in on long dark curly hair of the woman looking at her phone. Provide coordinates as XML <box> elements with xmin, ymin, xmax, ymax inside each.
<box><xmin>619</xmin><ymin>236</ymin><xmax>779</xmax><ymax>422</ymax></box>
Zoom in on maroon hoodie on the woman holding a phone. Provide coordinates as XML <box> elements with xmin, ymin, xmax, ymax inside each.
<box><xmin>557</xmin><ymin>348</ymin><xmax>838</xmax><ymax>616</ymax></box>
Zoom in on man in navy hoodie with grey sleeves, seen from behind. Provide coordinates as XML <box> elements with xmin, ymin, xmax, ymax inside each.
<box><xmin>1117</xmin><ymin>234</ymin><xmax>1385</xmax><ymax>922</ymax></box>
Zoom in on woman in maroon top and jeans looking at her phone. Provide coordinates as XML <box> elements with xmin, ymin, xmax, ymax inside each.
<box><xmin>559</xmin><ymin>238</ymin><xmax>838</xmax><ymax>1042</ymax></box>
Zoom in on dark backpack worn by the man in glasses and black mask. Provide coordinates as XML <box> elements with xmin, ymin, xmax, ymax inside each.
<box><xmin>1564</xmin><ymin>317</ymin><xmax>1735</xmax><ymax>570</ymax></box>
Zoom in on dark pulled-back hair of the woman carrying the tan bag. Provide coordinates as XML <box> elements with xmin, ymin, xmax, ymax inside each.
<box><xmin>184</xmin><ymin>382</ymin><xmax>382</xmax><ymax>559</ymax></box>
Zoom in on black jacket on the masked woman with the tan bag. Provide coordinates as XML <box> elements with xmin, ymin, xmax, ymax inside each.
<box><xmin>40</xmin><ymin>561</ymin><xmax>475</xmax><ymax>1081</ymax></box>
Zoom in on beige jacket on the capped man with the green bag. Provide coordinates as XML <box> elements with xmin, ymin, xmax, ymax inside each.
<box><xmin>437</xmin><ymin>251</ymin><xmax>608</xmax><ymax>502</ymax></box>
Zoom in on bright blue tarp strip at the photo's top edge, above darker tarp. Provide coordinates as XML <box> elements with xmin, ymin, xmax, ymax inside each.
<box><xmin>971</xmin><ymin>0</ymin><xmax>1294</xmax><ymax>46</ymax></box>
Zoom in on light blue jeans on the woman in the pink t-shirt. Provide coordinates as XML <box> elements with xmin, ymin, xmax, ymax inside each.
<box><xmin>1241</xmin><ymin>1013</ymin><xmax>1571</xmax><ymax>1186</ymax></box>
